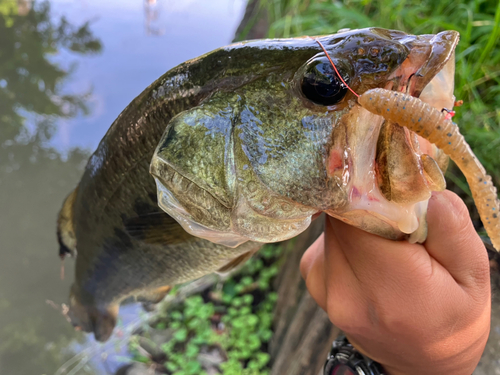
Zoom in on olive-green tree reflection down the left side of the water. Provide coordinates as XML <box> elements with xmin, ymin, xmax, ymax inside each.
<box><xmin>0</xmin><ymin>0</ymin><xmax>102</xmax><ymax>375</ymax></box>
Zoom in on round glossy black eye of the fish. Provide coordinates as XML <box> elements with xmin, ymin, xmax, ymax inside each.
<box><xmin>301</xmin><ymin>57</ymin><xmax>350</xmax><ymax>106</ymax></box>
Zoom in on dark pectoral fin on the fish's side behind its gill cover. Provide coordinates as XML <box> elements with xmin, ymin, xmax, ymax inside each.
<box><xmin>123</xmin><ymin>212</ymin><xmax>194</xmax><ymax>245</ymax></box>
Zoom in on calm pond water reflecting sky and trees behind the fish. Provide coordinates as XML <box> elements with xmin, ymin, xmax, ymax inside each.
<box><xmin>0</xmin><ymin>0</ymin><xmax>245</xmax><ymax>375</ymax></box>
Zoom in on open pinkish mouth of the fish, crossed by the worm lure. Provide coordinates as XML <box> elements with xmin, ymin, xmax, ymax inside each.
<box><xmin>327</xmin><ymin>31</ymin><xmax>459</xmax><ymax>242</ymax></box>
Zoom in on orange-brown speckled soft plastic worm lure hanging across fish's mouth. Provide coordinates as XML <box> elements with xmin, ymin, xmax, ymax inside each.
<box><xmin>358</xmin><ymin>89</ymin><xmax>500</xmax><ymax>251</ymax></box>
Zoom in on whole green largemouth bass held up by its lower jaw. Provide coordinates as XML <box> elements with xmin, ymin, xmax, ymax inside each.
<box><xmin>57</xmin><ymin>28</ymin><xmax>459</xmax><ymax>341</ymax></box>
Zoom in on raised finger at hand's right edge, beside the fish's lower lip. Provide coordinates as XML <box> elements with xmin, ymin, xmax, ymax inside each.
<box><xmin>425</xmin><ymin>190</ymin><xmax>489</xmax><ymax>285</ymax></box>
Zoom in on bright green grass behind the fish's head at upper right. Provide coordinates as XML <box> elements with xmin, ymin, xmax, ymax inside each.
<box><xmin>261</xmin><ymin>0</ymin><xmax>500</xmax><ymax>186</ymax></box>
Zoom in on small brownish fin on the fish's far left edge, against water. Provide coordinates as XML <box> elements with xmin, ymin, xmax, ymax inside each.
<box><xmin>57</xmin><ymin>188</ymin><xmax>78</xmax><ymax>259</ymax></box>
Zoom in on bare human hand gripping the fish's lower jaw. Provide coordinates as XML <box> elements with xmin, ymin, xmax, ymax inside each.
<box><xmin>300</xmin><ymin>191</ymin><xmax>491</xmax><ymax>375</ymax></box>
